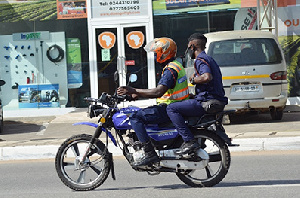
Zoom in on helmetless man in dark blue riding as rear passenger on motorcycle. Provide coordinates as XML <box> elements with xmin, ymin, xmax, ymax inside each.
<box><xmin>167</xmin><ymin>33</ymin><xmax>228</xmax><ymax>155</ymax></box>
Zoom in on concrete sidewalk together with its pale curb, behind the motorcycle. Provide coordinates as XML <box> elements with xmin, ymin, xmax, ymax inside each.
<box><xmin>0</xmin><ymin>108</ymin><xmax>300</xmax><ymax>160</ymax></box>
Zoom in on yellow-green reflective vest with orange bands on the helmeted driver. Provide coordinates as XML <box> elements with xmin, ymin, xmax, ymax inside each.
<box><xmin>156</xmin><ymin>60</ymin><xmax>189</xmax><ymax>104</ymax></box>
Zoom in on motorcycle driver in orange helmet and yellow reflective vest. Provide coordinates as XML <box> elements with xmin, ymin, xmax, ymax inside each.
<box><xmin>117</xmin><ymin>37</ymin><xmax>189</xmax><ymax>166</ymax></box>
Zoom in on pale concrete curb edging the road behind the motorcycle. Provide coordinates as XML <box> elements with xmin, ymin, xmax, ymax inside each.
<box><xmin>0</xmin><ymin>136</ymin><xmax>300</xmax><ymax>161</ymax></box>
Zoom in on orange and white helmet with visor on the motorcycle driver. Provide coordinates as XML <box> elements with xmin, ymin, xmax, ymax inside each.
<box><xmin>144</xmin><ymin>37</ymin><xmax>177</xmax><ymax>63</ymax></box>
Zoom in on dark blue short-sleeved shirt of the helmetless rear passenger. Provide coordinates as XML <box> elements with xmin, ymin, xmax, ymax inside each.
<box><xmin>195</xmin><ymin>51</ymin><xmax>228</xmax><ymax>104</ymax></box>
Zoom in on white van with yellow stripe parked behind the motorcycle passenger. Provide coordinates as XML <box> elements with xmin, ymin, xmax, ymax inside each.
<box><xmin>191</xmin><ymin>30</ymin><xmax>288</xmax><ymax>120</ymax></box>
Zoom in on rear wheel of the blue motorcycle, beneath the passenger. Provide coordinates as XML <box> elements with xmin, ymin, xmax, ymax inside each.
<box><xmin>176</xmin><ymin>130</ymin><xmax>230</xmax><ymax>187</ymax></box>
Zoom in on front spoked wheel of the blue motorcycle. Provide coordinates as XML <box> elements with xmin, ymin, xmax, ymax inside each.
<box><xmin>55</xmin><ymin>134</ymin><xmax>111</xmax><ymax>191</ymax></box>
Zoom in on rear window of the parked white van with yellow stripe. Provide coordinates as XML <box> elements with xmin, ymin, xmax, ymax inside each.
<box><xmin>207</xmin><ymin>38</ymin><xmax>282</xmax><ymax>67</ymax></box>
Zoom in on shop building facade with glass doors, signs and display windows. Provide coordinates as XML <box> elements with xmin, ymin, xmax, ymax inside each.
<box><xmin>0</xmin><ymin>0</ymin><xmax>300</xmax><ymax>109</ymax></box>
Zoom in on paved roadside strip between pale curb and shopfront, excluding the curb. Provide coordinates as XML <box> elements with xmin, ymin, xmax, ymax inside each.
<box><xmin>0</xmin><ymin>109</ymin><xmax>300</xmax><ymax>144</ymax></box>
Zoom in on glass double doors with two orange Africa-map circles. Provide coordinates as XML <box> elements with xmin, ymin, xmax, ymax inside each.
<box><xmin>95</xmin><ymin>24</ymin><xmax>148</xmax><ymax>96</ymax></box>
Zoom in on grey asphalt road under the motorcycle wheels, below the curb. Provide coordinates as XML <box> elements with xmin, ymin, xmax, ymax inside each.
<box><xmin>0</xmin><ymin>151</ymin><xmax>300</xmax><ymax>198</ymax></box>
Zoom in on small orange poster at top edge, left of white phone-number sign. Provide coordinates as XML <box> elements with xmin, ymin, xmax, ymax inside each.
<box><xmin>56</xmin><ymin>0</ymin><xmax>87</xmax><ymax>19</ymax></box>
